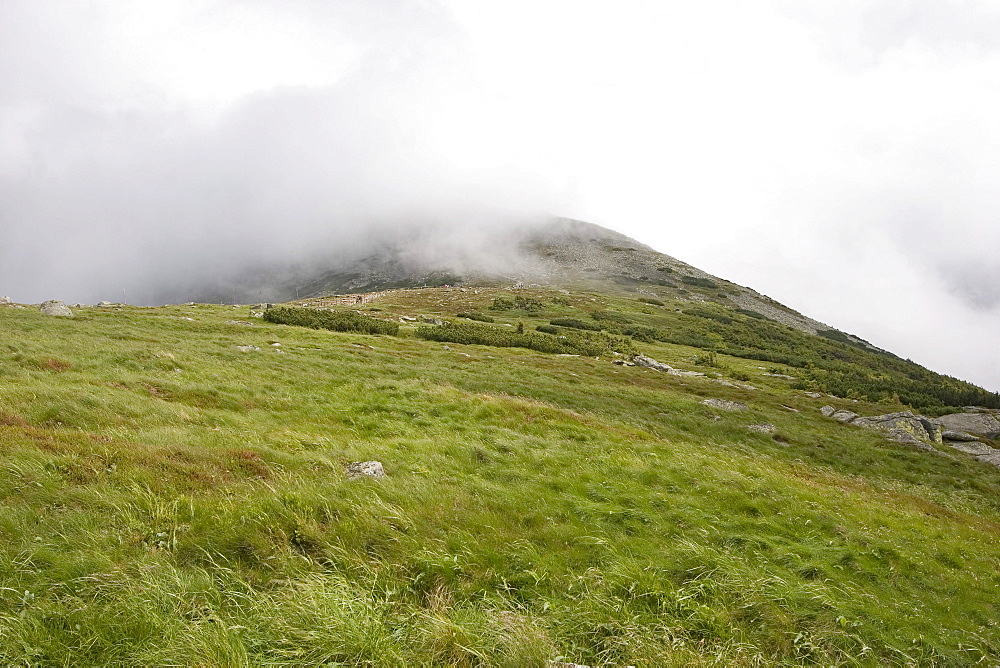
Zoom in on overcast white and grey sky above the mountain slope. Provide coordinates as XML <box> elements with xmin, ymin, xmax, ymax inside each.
<box><xmin>0</xmin><ymin>0</ymin><xmax>1000</xmax><ymax>390</ymax></box>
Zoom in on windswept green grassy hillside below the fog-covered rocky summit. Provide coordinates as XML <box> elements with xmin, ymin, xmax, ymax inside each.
<box><xmin>0</xmin><ymin>285</ymin><xmax>1000</xmax><ymax>666</ymax></box>
